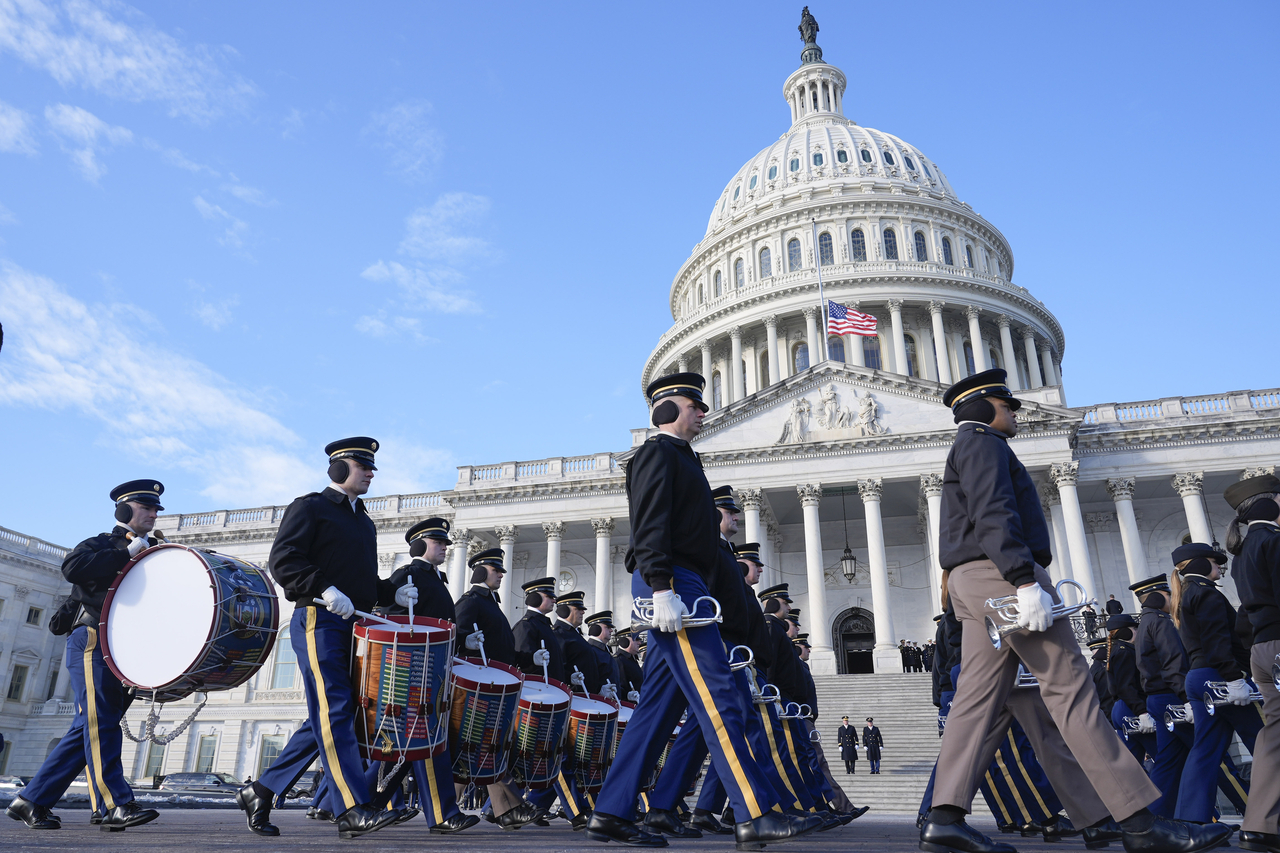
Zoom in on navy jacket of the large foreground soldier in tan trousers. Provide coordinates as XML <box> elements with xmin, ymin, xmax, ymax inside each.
<box><xmin>938</xmin><ymin>423</ymin><xmax>1052</xmax><ymax>587</ymax></box>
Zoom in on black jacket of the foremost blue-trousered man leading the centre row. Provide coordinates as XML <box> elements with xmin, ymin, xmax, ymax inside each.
<box><xmin>626</xmin><ymin>433</ymin><xmax>721</xmax><ymax>589</ymax></box>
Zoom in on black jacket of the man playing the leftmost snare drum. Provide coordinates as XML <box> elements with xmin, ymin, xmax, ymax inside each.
<box><xmin>270</xmin><ymin>487</ymin><xmax>396</xmax><ymax>611</ymax></box>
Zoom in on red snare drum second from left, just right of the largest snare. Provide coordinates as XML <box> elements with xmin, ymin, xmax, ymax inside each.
<box><xmin>449</xmin><ymin>657</ymin><xmax>525</xmax><ymax>785</ymax></box>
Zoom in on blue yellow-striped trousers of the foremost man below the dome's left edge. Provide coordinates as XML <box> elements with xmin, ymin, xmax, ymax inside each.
<box><xmin>595</xmin><ymin>566</ymin><xmax>778</xmax><ymax>821</ymax></box>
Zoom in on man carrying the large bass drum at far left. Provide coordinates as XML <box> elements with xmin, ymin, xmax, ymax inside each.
<box><xmin>6</xmin><ymin>480</ymin><xmax>164</xmax><ymax>833</ymax></box>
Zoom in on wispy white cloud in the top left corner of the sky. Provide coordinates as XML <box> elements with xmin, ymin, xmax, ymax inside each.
<box><xmin>0</xmin><ymin>0</ymin><xmax>257</xmax><ymax>122</ymax></box>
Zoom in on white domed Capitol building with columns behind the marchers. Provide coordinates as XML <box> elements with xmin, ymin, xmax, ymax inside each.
<box><xmin>0</xmin><ymin>21</ymin><xmax>1280</xmax><ymax>779</ymax></box>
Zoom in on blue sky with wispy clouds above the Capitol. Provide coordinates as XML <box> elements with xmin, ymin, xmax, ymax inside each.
<box><xmin>0</xmin><ymin>0</ymin><xmax>1280</xmax><ymax>543</ymax></box>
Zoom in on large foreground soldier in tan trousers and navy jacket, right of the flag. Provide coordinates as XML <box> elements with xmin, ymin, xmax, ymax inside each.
<box><xmin>920</xmin><ymin>368</ymin><xmax>1231</xmax><ymax>853</ymax></box>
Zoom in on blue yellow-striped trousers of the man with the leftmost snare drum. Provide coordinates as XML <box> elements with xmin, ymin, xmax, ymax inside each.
<box><xmin>259</xmin><ymin>607</ymin><xmax>369</xmax><ymax>815</ymax></box>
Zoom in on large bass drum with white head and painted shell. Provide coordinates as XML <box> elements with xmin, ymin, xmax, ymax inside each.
<box><xmin>99</xmin><ymin>543</ymin><xmax>280</xmax><ymax>702</ymax></box>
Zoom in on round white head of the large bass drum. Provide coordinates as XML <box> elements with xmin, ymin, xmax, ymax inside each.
<box><xmin>102</xmin><ymin>547</ymin><xmax>216</xmax><ymax>689</ymax></box>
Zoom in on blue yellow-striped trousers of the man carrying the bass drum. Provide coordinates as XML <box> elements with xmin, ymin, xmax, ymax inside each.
<box><xmin>22</xmin><ymin>625</ymin><xmax>133</xmax><ymax>812</ymax></box>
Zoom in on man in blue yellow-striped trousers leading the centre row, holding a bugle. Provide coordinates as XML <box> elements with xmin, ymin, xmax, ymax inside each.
<box><xmin>586</xmin><ymin>373</ymin><xmax>822</xmax><ymax>847</ymax></box>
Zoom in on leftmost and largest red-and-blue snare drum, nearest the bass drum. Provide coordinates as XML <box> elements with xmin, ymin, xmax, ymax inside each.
<box><xmin>351</xmin><ymin>616</ymin><xmax>454</xmax><ymax>761</ymax></box>
